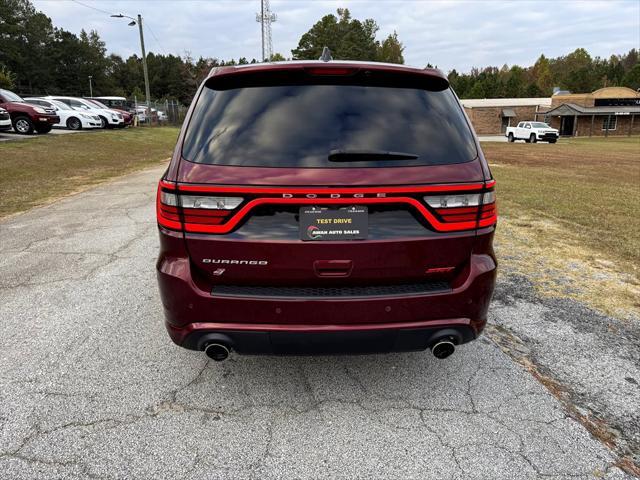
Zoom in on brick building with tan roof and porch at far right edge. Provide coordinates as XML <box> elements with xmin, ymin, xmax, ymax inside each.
<box><xmin>538</xmin><ymin>87</ymin><xmax>640</xmax><ymax>137</ymax></box>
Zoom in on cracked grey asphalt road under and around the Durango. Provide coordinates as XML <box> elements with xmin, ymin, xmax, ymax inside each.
<box><xmin>0</xmin><ymin>168</ymin><xmax>637</xmax><ymax>480</ymax></box>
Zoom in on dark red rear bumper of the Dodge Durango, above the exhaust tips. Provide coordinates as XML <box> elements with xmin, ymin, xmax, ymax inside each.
<box><xmin>157</xmin><ymin>231</ymin><xmax>496</xmax><ymax>354</ymax></box>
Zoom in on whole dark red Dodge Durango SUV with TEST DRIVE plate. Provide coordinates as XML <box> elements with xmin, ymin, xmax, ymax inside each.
<box><xmin>157</xmin><ymin>61</ymin><xmax>497</xmax><ymax>360</ymax></box>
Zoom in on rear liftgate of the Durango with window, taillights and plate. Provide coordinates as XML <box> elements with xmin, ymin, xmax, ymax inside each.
<box><xmin>159</xmin><ymin>66</ymin><xmax>494</xmax><ymax>295</ymax></box>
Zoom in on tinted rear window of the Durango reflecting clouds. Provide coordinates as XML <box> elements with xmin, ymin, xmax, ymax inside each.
<box><xmin>183</xmin><ymin>84</ymin><xmax>477</xmax><ymax>168</ymax></box>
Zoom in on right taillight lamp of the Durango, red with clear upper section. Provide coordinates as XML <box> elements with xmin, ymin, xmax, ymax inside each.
<box><xmin>424</xmin><ymin>183</ymin><xmax>497</xmax><ymax>227</ymax></box>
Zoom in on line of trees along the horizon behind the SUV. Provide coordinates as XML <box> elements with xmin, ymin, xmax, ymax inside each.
<box><xmin>0</xmin><ymin>0</ymin><xmax>640</xmax><ymax>104</ymax></box>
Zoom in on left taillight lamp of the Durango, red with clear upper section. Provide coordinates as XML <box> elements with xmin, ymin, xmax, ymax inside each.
<box><xmin>157</xmin><ymin>181</ymin><xmax>243</xmax><ymax>231</ymax></box>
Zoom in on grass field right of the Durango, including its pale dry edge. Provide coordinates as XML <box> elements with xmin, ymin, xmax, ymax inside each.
<box><xmin>482</xmin><ymin>137</ymin><xmax>640</xmax><ymax>313</ymax></box>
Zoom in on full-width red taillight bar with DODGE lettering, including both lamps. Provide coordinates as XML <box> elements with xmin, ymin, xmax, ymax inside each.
<box><xmin>157</xmin><ymin>180</ymin><xmax>497</xmax><ymax>234</ymax></box>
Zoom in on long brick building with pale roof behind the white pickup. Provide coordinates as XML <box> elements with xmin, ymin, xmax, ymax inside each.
<box><xmin>460</xmin><ymin>98</ymin><xmax>552</xmax><ymax>135</ymax></box>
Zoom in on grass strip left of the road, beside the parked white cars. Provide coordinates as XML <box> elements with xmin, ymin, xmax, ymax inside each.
<box><xmin>0</xmin><ymin>127</ymin><xmax>179</xmax><ymax>218</ymax></box>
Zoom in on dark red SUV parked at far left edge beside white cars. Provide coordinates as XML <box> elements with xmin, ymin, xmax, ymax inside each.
<box><xmin>0</xmin><ymin>89</ymin><xmax>60</xmax><ymax>135</ymax></box>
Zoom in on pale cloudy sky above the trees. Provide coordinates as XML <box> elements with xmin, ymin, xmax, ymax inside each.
<box><xmin>32</xmin><ymin>0</ymin><xmax>640</xmax><ymax>72</ymax></box>
